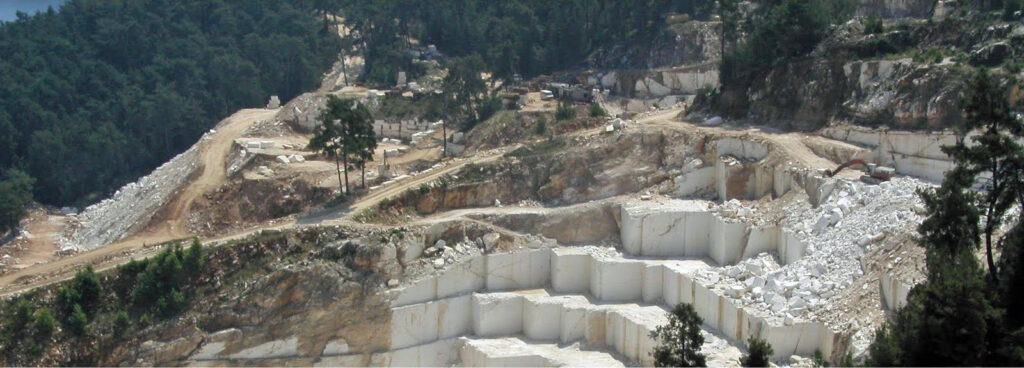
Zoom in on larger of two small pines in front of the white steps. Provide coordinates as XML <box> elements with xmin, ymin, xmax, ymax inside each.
<box><xmin>650</xmin><ymin>303</ymin><xmax>707</xmax><ymax>367</ymax></box>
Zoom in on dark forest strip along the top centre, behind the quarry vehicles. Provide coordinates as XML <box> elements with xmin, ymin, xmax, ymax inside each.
<box><xmin>324</xmin><ymin>0</ymin><xmax>712</xmax><ymax>85</ymax></box>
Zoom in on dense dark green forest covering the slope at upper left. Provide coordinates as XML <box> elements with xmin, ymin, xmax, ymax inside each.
<box><xmin>0</xmin><ymin>0</ymin><xmax>340</xmax><ymax>205</ymax></box>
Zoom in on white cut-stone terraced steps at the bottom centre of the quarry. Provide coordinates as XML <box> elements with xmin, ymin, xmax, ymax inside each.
<box><xmin>376</xmin><ymin>199</ymin><xmax>848</xmax><ymax>366</ymax></box>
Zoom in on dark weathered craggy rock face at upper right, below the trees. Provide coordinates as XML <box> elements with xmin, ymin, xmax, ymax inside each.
<box><xmin>750</xmin><ymin>59</ymin><xmax>966</xmax><ymax>129</ymax></box>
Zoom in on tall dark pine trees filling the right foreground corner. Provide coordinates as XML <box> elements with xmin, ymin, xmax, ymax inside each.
<box><xmin>867</xmin><ymin>68</ymin><xmax>1024</xmax><ymax>366</ymax></box>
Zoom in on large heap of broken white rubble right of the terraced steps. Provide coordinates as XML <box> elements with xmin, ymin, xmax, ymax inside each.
<box><xmin>698</xmin><ymin>177</ymin><xmax>929</xmax><ymax>338</ymax></box>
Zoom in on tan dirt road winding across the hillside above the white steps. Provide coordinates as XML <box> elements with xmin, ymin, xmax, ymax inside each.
<box><xmin>0</xmin><ymin>109</ymin><xmax>856</xmax><ymax>294</ymax></box>
